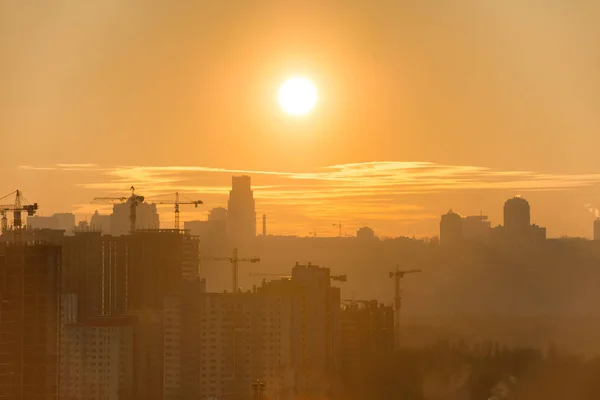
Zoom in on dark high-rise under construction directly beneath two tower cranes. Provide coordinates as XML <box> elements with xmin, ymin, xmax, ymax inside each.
<box><xmin>125</xmin><ymin>230</ymin><xmax>201</xmax><ymax>400</ymax></box>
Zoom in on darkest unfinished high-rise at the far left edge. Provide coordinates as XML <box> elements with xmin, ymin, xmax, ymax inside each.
<box><xmin>0</xmin><ymin>243</ymin><xmax>61</xmax><ymax>400</ymax></box>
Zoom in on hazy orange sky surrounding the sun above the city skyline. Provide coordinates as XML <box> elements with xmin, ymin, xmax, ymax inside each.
<box><xmin>0</xmin><ymin>0</ymin><xmax>600</xmax><ymax>236</ymax></box>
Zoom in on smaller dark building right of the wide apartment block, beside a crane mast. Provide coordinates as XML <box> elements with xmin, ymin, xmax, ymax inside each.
<box><xmin>341</xmin><ymin>300</ymin><xmax>394</xmax><ymax>376</ymax></box>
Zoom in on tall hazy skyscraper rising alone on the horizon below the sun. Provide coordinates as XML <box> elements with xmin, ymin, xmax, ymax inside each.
<box><xmin>227</xmin><ymin>175</ymin><xmax>256</xmax><ymax>243</ymax></box>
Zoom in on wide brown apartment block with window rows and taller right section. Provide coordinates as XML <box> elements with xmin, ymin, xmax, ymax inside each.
<box><xmin>200</xmin><ymin>265</ymin><xmax>340</xmax><ymax>399</ymax></box>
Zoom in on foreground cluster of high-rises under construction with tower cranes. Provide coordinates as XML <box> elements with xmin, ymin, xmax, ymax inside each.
<box><xmin>0</xmin><ymin>178</ymin><xmax>406</xmax><ymax>400</ymax></box>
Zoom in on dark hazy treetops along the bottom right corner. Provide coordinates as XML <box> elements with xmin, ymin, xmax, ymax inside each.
<box><xmin>340</xmin><ymin>342</ymin><xmax>600</xmax><ymax>400</ymax></box>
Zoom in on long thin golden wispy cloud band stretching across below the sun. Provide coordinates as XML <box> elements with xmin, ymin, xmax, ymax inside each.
<box><xmin>21</xmin><ymin>161</ymin><xmax>600</xmax><ymax>198</ymax></box>
